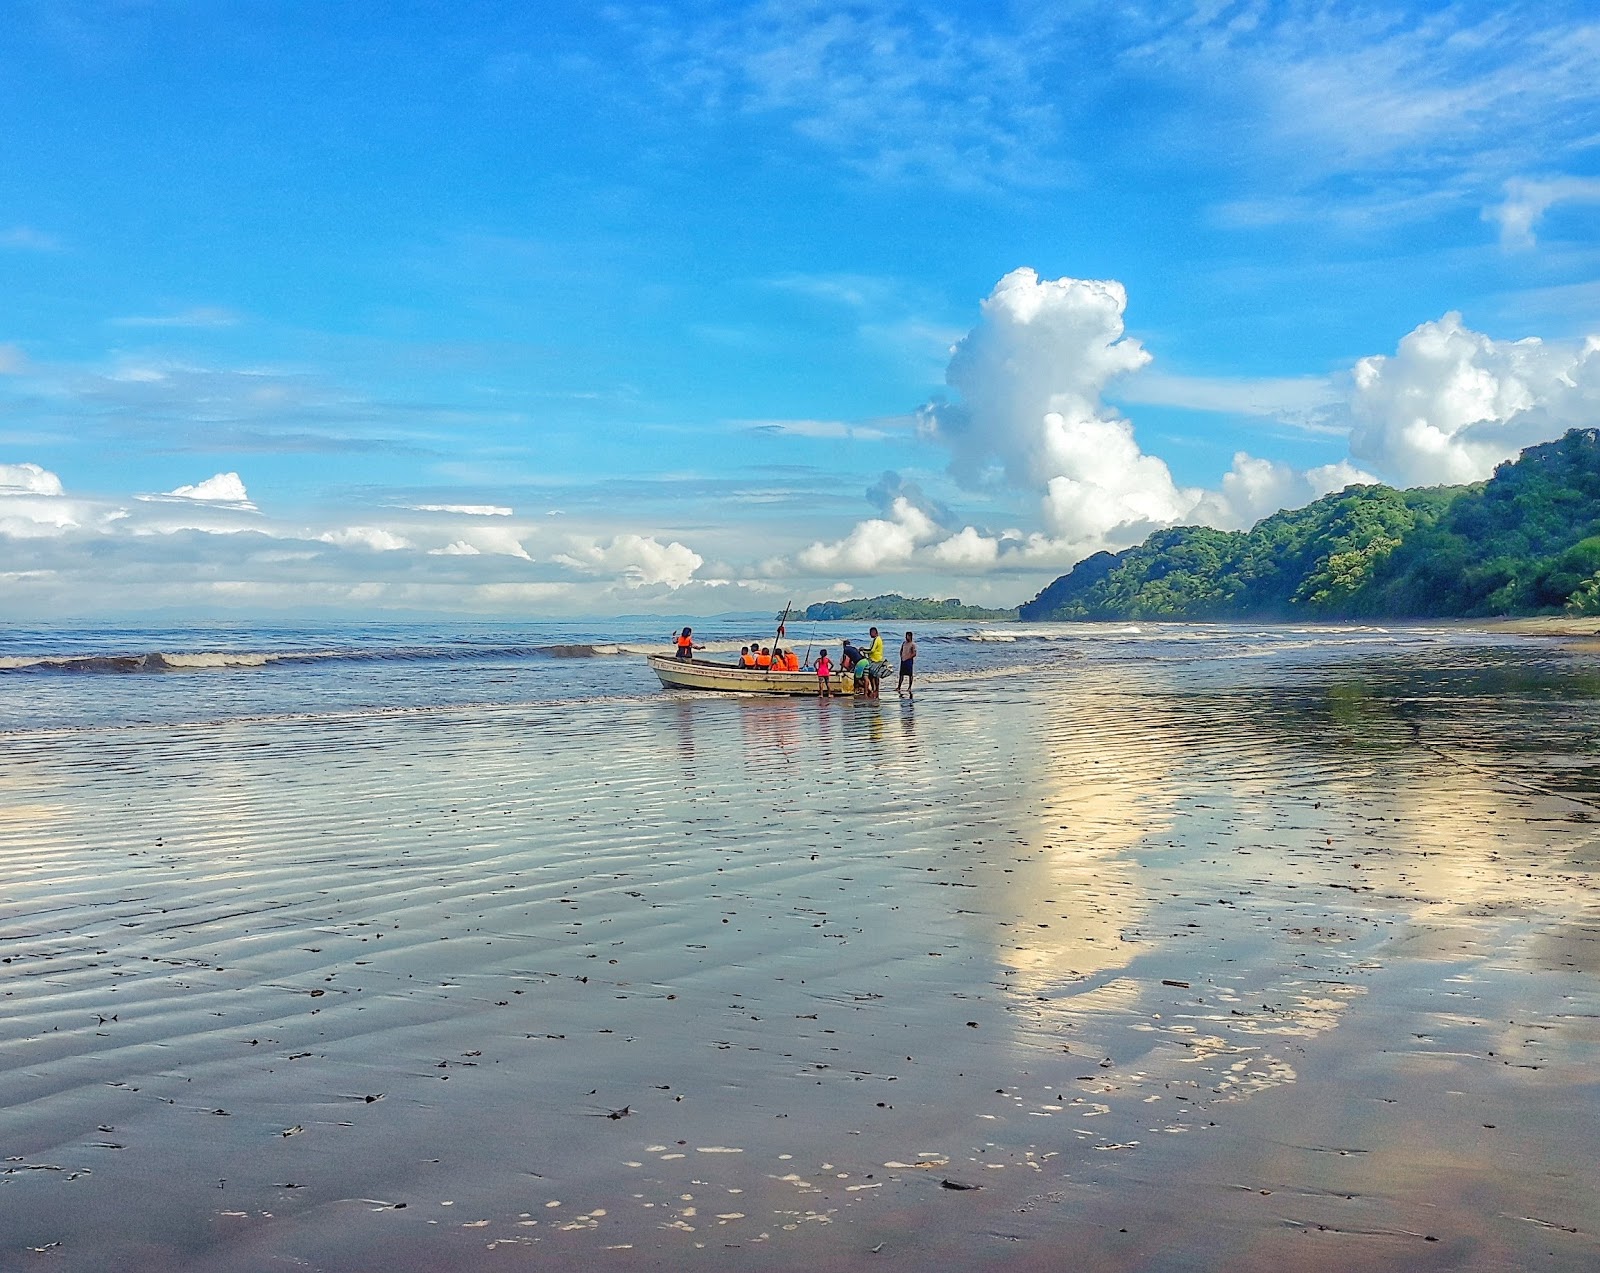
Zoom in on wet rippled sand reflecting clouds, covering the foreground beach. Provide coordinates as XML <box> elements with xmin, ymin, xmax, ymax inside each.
<box><xmin>0</xmin><ymin>665</ymin><xmax>1600</xmax><ymax>1270</ymax></box>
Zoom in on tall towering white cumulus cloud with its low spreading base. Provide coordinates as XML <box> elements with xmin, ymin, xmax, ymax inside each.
<box><xmin>795</xmin><ymin>269</ymin><xmax>1401</xmax><ymax>585</ymax></box>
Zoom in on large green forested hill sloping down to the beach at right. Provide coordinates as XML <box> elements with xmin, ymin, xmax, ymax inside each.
<box><xmin>1021</xmin><ymin>429</ymin><xmax>1600</xmax><ymax>621</ymax></box>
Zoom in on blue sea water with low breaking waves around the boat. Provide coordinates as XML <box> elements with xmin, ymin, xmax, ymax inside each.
<box><xmin>0</xmin><ymin>617</ymin><xmax>1595</xmax><ymax>734</ymax></box>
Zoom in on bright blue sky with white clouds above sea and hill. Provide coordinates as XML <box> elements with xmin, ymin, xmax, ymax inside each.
<box><xmin>0</xmin><ymin>0</ymin><xmax>1600</xmax><ymax>622</ymax></box>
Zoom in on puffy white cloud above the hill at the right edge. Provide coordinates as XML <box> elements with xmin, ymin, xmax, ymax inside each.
<box><xmin>1350</xmin><ymin>313</ymin><xmax>1600</xmax><ymax>486</ymax></box>
